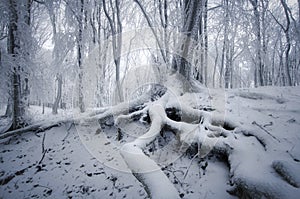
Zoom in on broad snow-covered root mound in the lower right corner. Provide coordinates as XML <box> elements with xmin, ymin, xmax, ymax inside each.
<box><xmin>224</xmin><ymin>134</ymin><xmax>300</xmax><ymax>199</ymax></box>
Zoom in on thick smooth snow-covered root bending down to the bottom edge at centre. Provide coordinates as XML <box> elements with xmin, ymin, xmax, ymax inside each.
<box><xmin>120</xmin><ymin>93</ymin><xmax>179</xmax><ymax>199</ymax></box>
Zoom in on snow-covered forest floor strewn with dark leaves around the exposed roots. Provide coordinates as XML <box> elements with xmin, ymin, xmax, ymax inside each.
<box><xmin>0</xmin><ymin>87</ymin><xmax>300</xmax><ymax>198</ymax></box>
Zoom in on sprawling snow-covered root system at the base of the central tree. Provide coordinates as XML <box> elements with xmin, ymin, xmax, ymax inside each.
<box><xmin>0</xmin><ymin>75</ymin><xmax>300</xmax><ymax>198</ymax></box>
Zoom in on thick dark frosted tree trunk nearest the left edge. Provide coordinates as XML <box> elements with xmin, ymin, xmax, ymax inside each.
<box><xmin>7</xmin><ymin>0</ymin><xmax>32</xmax><ymax>129</ymax></box>
